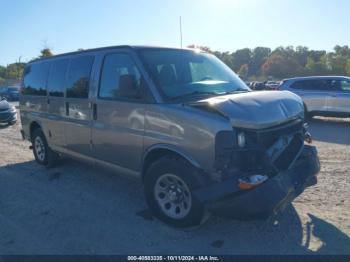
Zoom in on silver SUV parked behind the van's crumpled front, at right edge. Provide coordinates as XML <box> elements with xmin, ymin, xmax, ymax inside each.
<box><xmin>279</xmin><ymin>76</ymin><xmax>350</xmax><ymax>117</ymax></box>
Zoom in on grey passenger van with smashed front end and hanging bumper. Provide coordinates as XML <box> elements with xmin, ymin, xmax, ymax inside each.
<box><xmin>20</xmin><ymin>46</ymin><xmax>320</xmax><ymax>227</ymax></box>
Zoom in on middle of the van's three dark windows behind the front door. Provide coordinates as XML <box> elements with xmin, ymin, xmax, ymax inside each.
<box><xmin>47</xmin><ymin>59</ymin><xmax>69</xmax><ymax>97</ymax></box>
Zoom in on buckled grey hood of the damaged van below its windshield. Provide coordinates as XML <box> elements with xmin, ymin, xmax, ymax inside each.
<box><xmin>193</xmin><ymin>91</ymin><xmax>304</xmax><ymax>129</ymax></box>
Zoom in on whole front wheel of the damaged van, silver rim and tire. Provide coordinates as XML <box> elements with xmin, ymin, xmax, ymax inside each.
<box><xmin>145</xmin><ymin>157</ymin><xmax>204</xmax><ymax>227</ymax></box>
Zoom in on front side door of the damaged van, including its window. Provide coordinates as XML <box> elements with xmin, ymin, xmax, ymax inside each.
<box><xmin>92</xmin><ymin>52</ymin><xmax>147</xmax><ymax>171</ymax></box>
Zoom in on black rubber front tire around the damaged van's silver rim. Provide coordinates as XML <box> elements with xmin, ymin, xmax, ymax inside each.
<box><xmin>144</xmin><ymin>156</ymin><xmax>205</xmax><ymax>227</ymax></box>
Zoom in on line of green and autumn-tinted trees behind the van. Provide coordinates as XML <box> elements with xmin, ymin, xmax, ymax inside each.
<box><xmin>0</xmin><ymin>45</ymin><xmax>350</xmax><ymax>86</ymax></box>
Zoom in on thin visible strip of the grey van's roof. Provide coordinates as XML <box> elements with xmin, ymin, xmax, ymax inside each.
<box><xmin>28</xmin><ymin>45</ymin><xmax>198</xmax><ymax>64</ymax></box>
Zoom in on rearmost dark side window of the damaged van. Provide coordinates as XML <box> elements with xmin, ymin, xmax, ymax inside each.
<box><xmin>22</xmin><ymin>62</ymin><xmax>50</xmax><ymax>96</ymax></box>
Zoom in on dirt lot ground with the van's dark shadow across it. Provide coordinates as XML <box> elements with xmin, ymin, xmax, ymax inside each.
<box><xmin>0</xmin><ymin>110</ymin><xmax>350</xmax><ymax>254</ymax></box>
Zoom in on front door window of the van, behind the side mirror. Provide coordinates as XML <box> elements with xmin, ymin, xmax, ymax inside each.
<box><xmin>99</xmin><ymin>53</ymin><xmax>145</xmax><ymax>101</ymax></box>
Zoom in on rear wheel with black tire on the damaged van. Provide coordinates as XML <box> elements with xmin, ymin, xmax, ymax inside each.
<box><xmin>32</xmin><ymin>128</ymin><xmax>58</xmax><ymax>167</ymax></box>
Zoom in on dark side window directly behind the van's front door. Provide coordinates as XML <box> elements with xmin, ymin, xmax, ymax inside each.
<box><xmin>66</xmin><ymin>56</ymin><xmax>94</xmax><ymax>98</ymax></box>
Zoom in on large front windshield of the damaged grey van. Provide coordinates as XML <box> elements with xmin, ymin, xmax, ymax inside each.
<box><xmin>140</xmin><ymin>49</ymin><xmax>250</xmax><ymax>101</ymax></box>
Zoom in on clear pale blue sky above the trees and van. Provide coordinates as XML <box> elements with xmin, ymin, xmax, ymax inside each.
<box><xmin>0</xmin><ymin>0</ymin><xmax>350</xmax><ymax>65</ymax></box>
